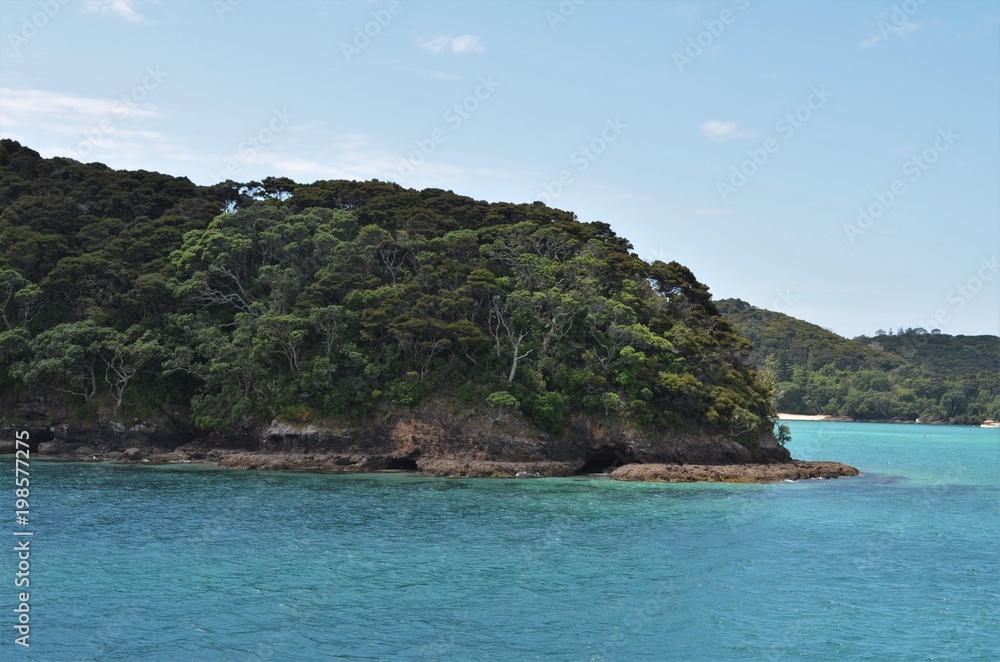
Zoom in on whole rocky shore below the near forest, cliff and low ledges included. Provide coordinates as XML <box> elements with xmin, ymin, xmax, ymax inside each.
<box><xmin>0</xmin><ymin>407</ymin><xmax>860</xmax><ymax>482</ymax></box>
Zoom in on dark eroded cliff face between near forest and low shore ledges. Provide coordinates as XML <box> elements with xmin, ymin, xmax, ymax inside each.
<box><xmin>0</xmin><ymin>408</ymin><xmax>791</xmax><ymax>475</ymax></box>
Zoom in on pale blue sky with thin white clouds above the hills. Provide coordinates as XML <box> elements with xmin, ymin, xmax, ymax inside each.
<box><xmin>0</xmin><ymin>0</ymin><xmax>1000</xmax><ymax>337</ymax></box>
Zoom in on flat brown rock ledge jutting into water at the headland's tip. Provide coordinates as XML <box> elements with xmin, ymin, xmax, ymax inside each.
<box><xmin>611</xmin><ymin>460</ymin><xmax>861</xmax><ymax>483</ymax></box>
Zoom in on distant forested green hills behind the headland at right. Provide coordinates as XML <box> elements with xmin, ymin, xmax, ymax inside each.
<box><xmin>718</xmin><ymin>299</ymin><xmax>1000</xmax><ymax>424</ymax></box>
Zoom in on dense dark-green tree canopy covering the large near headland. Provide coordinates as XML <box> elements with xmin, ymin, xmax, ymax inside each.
<box><xmin>0</xmin><ymin>140</ymin><xmax>773</xmax><ymax>444</ymax></box>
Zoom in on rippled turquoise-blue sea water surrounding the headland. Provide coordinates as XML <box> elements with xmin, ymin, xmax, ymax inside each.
<box><xmin>0</xmin><ymin>422</ymin><xmax>1000</xmax><ymax>662</ymax></box>
